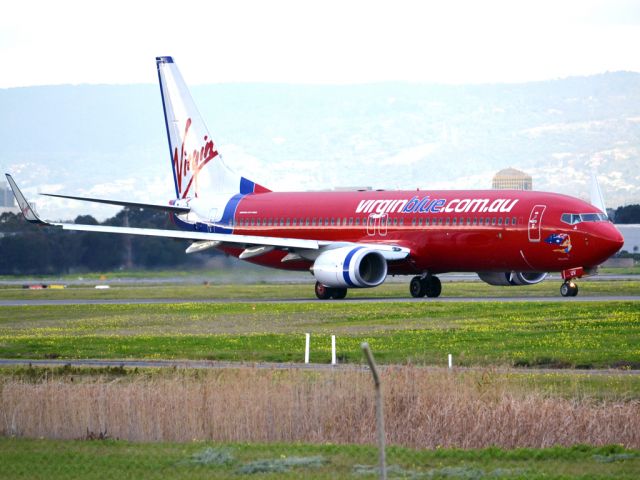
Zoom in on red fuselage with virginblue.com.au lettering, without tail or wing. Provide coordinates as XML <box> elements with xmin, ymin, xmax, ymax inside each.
<box><xmin>211</xmin><ymin>190</ymin><xmax>623</xmax><ymax>274</ymax></box>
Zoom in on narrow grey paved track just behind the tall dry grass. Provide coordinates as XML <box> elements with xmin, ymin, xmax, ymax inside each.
<box><xmin>0</xmin><ymin>358</ymin><xmax>640</xmax><ymax>376</ymax></box>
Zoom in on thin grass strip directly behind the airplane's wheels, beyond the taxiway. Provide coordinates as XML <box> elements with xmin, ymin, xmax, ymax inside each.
<box><xmin>0</xmin><ymin>278</ymin><xmax>640</xmax><ymax>302</ymax></box>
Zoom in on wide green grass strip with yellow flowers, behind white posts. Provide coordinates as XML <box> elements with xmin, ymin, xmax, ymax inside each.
<box><xmin>0</xmin><ymin>301</ymin><xmax>640</xmax><ymax>368</ymax></box>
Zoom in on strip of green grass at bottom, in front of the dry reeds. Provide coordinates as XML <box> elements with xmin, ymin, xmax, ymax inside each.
<box><xmin>0</xmin><ymin>438</ymin><xmax>640</xmax><ymax>480</ymax></box>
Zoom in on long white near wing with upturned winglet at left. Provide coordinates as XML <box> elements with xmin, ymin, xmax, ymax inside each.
<box><xmin>6</xmin><ymin>174</ymin><xmax>409</xmax><ymax>260</ymax></box>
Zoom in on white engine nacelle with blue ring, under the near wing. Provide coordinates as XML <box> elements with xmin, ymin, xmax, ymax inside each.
<box><xmin>311</xmin><ymin>247</ymin><xmax>387</xmax><ymax>288</ymax></box>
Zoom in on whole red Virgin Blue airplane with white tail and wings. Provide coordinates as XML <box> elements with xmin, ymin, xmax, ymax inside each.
<box><xmin>6</xmin><ymin>56</ymin><xmax>624</xmax><ymax>300</ymax></box>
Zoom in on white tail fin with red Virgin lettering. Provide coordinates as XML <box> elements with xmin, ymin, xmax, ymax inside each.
<box><xmin>156</xmin><ymin>57</ymin><xmax>270</xmax><ymax>198</ymax></box>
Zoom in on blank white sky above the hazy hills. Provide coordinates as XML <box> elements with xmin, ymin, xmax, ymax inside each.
<box><xmin>0</xmin><ymin>0</ymin><xmax>640</xmax><ymax>88</ymax></box>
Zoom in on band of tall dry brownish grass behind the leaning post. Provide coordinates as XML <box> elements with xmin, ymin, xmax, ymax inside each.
<box><xmin>0</xmin><ymin>367</ymin><xmax>640</xmax><ymax>448</ymax></box>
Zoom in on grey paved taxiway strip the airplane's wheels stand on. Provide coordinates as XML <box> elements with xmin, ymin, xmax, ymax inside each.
<box><xmin>0</xmin><ymin>295</ymin><xmax>640</xmax><ymax>307</ymax></box>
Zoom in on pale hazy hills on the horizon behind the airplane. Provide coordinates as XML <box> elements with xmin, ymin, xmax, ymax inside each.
<box><xmin>0</xmin><ymin>72</ymin><xmax>640</xmax><ymax>219</ymax></box>
